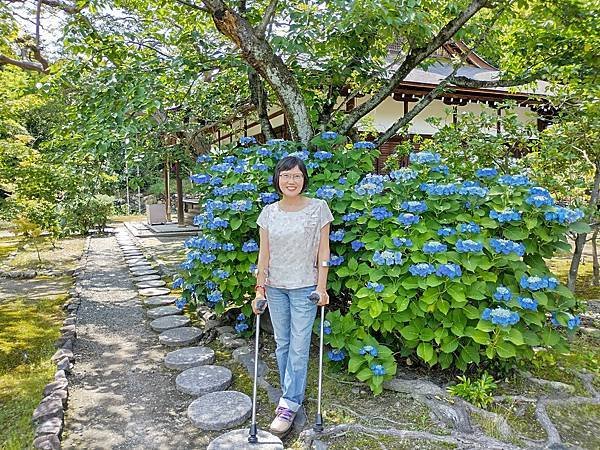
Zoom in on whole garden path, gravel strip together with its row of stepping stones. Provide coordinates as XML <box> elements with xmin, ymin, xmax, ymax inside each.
<box><xmin>63</xmin><ymin>229</ymin><xmax>276</xmax><ymax>449</ymax></box>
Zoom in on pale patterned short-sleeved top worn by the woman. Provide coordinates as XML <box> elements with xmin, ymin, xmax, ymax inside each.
<box><xmin>256</xmin><ymin>198</ymin><xmax>333</xmax><ymax>289</ymax></box>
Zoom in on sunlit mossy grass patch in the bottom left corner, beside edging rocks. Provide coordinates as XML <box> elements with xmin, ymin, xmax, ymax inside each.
<box><xmin>0</xmin><ymin>295</ymin><xmax>67</xmax><ymax>450</ymax></box>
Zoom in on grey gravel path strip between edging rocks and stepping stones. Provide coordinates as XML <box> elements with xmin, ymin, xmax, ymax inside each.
<box><xmin>63</xmin><ymin>237</ymin><xmax>209</xmax><ymax>449</ymax></box>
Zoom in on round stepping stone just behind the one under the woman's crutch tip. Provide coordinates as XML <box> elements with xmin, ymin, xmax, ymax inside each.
<box><xmin>188</xmin><ymin>391</ymin><xmax>252</xmax><ymax>430</ymax></box>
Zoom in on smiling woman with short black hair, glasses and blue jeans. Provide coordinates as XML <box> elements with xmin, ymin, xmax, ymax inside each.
<box><xmin>252</xmin><ymin>156</ymin><xmax>333</xmax><ymax>436</ymax></box>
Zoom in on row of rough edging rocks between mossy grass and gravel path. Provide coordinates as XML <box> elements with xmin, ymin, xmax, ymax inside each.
<box><xmin>32</xmin><ymin>236</ymin><xmax>91</xmax><ymax>450</ymax></box>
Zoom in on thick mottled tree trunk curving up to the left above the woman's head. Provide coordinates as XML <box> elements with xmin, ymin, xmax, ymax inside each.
<box><xmin>204</xmin><ymin>0</ymin><xmax>313</xmax><ymax>145</ymax></box>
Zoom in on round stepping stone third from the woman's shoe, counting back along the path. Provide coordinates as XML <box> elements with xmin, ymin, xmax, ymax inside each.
<box><xmin>175</xmin><ymin>364</ymin><xmax>232</xmax><ymax>396</ymax></box>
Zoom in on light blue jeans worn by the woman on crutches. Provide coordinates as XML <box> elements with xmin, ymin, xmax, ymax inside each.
<box><xmin>266</xmin><ymin>286</ymin><xmax>317</xmax><ymax>411</ymax></box>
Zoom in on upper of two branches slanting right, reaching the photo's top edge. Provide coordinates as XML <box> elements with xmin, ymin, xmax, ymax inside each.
<box><xmin>338</xmin><ymin>0</ymin><xmax>488</xmax><ymax>134</ymax></box>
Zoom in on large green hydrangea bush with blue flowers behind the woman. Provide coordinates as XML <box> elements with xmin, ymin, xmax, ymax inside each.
<box><xmin>175</xmin><ymin>132</ymin><xmax>583</xmax><ymax>393</ymax></box>
